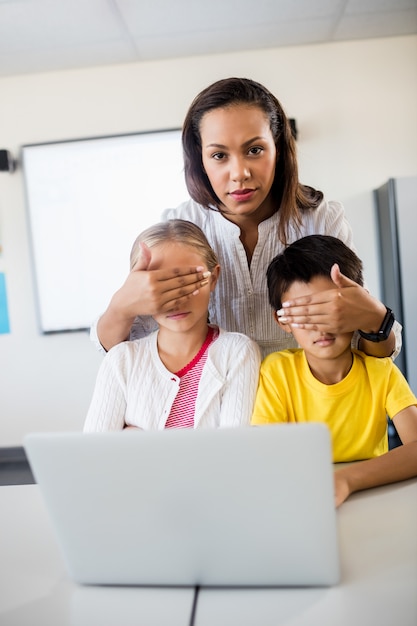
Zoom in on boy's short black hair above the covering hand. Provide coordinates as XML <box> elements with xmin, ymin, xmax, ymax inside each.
<box><xmin>266</xmin><ymin>235</ymin><xmax>363</xmax><ymax>311</ymax></box>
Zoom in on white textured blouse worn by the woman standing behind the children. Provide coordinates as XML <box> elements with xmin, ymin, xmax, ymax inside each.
<box><xmin>91</xmin><ymin>200</ymin><xmax>401</xmax><ymax>358</ymax></box>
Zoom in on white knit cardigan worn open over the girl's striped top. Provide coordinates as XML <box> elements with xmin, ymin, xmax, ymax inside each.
<box><xmin>84</xmin><ymin>329</ymin><xmax>260</xmax><ymax>432</ymax></box>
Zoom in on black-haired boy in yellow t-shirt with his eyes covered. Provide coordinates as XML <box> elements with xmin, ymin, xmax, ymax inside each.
<box><xmin>252</xmin><ymin>235</ymin><xmax>417</xmax><ymax>506</ymax></box>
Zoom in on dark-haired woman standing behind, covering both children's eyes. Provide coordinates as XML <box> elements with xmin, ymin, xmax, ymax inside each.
<box><xmin>92</xmin><ymin>78</ymin><xmax>401</xmax><ymax>357</ymax></box>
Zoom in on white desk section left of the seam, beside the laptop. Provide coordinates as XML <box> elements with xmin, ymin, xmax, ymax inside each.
<box><xmin>0</xmin><ymin>485</ymin><xmax>194</xmax><ymax>626</ymax></box>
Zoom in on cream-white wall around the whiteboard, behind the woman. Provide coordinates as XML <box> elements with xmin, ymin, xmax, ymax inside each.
<box><xmin>0</xmin><ymin>36</ymin><xmax>417</xmax><ymax>446</ymax></box>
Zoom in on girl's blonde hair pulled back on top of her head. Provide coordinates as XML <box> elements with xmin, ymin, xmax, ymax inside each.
<box><xmin>130</xmin><ymin>219</ymin><xmax>219</xmax><ymax>272</ymax></box>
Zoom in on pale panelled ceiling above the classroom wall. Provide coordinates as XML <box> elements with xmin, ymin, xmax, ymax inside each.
<box><xmin>0</xmin><ymin>0</ymin><xmax>417</xmax><ymax>76</ymax></box>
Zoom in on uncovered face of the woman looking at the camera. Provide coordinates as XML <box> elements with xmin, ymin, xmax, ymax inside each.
<box><xmin>200</xmin><ymin>104</ymin><xmax>277</xmax><ymax>224</ymax></box>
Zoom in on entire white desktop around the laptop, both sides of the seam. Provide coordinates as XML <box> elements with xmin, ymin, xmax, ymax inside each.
<box><xmin>0</xmin><ymin>480</ymin><xmax>417</xmax><ymax>626</ymax></box>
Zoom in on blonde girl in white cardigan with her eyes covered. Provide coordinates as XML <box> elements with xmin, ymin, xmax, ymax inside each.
<box><xmin>84</xmin><ymin>220</ymin><xmax>260</xmax><ymax>432</ymax></box>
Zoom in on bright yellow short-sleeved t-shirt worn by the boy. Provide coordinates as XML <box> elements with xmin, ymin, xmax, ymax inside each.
<box><xmin>252</xmin><ymin>349</ymin><xmax>417</xmax><ymax>463</ymax></box>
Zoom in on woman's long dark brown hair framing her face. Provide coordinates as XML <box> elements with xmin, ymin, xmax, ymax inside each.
<box><xmin>182</xmin><ymin>78</ymin><xmax>323</xmax><ymax>244</ymax></box>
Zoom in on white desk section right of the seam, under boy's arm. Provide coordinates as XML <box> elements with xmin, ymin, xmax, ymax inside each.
<box><xmin>195</xmin><ymin>480</ymin><xmax>417</xmax><ymax>626</ymax></box>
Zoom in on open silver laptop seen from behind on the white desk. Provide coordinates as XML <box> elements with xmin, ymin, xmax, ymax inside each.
<box><xmin>24</xmin><ymin>423</ymin><xmax>340</xmax><ymax>587</ymax></box>
